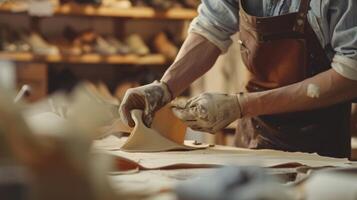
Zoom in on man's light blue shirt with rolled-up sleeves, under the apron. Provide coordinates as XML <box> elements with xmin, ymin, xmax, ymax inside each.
<box><xmin>189</xmin><ymin>0</ymin><xmax>357</xmax><ymax>80</ymax></box>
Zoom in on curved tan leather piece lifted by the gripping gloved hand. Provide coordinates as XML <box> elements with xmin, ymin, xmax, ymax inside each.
<box><xmin>121</xmin><ymin>110</ymin><xmax>208</xmax><ymax>152</ymax></box>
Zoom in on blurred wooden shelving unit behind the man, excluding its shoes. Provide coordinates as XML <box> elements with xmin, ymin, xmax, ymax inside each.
<box><xmin>0</xmin><ymin>2</ymin><xmax>198</xmax><ymax>101</ymax></box>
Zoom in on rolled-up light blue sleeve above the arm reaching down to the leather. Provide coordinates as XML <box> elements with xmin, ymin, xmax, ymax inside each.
<box><xmin>189</xmin><ymin>0</ymin><xmax>238</xmax><ymax>53</ymax></box>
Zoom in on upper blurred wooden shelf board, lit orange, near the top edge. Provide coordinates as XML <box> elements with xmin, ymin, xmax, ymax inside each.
<box><xmin>0</xmin><ymin>3</ymin><xmax>197</xmax><ymax>20</ymax></box>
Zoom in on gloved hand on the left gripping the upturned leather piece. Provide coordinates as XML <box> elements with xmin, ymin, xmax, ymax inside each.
<box><xmin>119</xmin><ymin>81</ymin><xmax>172</xmax><ymax>127</ymax></box>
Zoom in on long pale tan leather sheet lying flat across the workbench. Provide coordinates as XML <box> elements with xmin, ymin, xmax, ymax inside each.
<box><xmin>94</xmin><ymin>136</ymin><xmax>352</xmax><ymax>169</ymax></box>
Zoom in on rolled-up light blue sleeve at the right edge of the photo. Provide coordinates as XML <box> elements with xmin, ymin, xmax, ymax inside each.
<box><xmin>325</xmin><ymin>0</ymin><xmax>357</xmax><ymax>80</ymax></box>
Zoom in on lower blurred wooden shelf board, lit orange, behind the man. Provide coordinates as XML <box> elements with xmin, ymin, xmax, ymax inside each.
<box><xmin>0</xmin><ymin>52</ymin><xmax>167</xmax><ymax>65</ymax></box>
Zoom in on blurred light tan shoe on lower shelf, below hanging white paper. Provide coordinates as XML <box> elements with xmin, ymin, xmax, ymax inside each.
<box><xmin>21</xmin><ymin>32</ymin><xmax>59</xmax><ymax>55</ymax></box>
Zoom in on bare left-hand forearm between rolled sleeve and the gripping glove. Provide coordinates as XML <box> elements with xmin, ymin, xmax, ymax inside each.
<box><xmin>161</xmin><ymin>33</ymin><xmax>221</xmax><ymax>98</ymax></box>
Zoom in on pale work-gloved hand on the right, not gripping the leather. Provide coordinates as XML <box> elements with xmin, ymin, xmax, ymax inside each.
<box><xmin>172</xmin><ymin>93</ymin><xmax>241</xmax><ymax>133</ymax></box>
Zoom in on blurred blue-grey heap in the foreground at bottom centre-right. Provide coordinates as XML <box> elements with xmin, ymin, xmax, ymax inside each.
<box><xmin>176</xmin><ymin>167</ymin><xmax>294</xmax><ymax>200</ymax></box>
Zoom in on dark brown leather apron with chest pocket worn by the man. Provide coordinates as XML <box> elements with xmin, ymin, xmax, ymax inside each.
<box><xmin>236</xmin><ymin>0</ymin><xmax>351</xmax><ymax>157</ymax></box>
